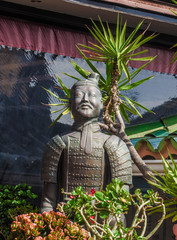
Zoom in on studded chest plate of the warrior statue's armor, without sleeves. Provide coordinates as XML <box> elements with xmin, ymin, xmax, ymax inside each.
<box><xmin>65</xmin><ymin>136</ymin><xmax>104</xmax><ymax>192</ymax></box>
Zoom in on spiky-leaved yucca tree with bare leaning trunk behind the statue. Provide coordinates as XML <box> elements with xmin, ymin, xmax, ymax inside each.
<box><xmin>43</xmin><ymin>17</ymin><xmax>156</xmax><ymax>178</ymax></box>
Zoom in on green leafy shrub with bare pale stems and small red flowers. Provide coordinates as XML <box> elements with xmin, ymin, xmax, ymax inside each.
<box><xmin>61</xmin><ymin>178</ymin><xmax>165</xmax><ymax>240</ymax></box>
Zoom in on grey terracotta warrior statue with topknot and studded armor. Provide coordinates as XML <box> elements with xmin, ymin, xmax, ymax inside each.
<box><xmin>41</xmin><ymin>73</ymin><xmax>132</xmax><ymax>212</ymax></box>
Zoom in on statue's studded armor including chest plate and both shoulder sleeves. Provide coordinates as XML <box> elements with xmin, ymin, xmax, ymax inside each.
<box><xmin>42</xmin><ymin>132</ymin><xmax>132</xmax><ymax>200</ymax></box>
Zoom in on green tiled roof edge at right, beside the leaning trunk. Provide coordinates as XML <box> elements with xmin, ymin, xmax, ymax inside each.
<box><xmin>126</xmin><ymin>114</ymin><xmax>177</xmax><ymax>153</ymax></box>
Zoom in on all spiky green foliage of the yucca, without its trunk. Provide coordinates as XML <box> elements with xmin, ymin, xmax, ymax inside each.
<box><xmin>42</xmin><ymin>16</ymin><xmax>156</xmax><ymax>122</ymax></box>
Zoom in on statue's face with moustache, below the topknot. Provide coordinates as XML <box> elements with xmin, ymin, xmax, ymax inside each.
<box><xmin>71</xmin><ymin>85</ymin><xmax>103</xmax><ymax>119</ymax></box>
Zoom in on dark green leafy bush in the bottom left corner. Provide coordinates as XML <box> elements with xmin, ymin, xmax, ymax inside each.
<box><xmin>0</xmin><ymin>184</ymin><xmax>38</xmax><ymax>240</ymax></box>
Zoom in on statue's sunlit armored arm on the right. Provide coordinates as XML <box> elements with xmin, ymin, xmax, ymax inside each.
<box><xmin>104</xmin><ymin>135</ymin><xmax>132</xmax><ymax>190</ymax></box>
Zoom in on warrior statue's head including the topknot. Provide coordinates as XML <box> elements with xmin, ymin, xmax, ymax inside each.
<box><xmin>70</xmin><ymin>73</ymin><xmax>103</xmax><ymax>120</ymax></box>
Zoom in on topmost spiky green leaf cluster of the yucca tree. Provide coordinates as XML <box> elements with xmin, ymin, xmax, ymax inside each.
<box><xmin>78</xmin><ymin>16</ymin><xmax>157</xmax><ymax>78</ymax></box>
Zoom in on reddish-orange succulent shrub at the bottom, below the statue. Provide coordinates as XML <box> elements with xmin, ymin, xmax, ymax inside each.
<box><xmin>11</xmin><ymin>211</ymin><xmax>91</xmax><ymax>240</ymax></box>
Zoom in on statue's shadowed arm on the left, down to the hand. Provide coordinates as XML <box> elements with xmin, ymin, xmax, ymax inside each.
<box><xmin>41</xmin><ymin>135</ymin><xmax>65</xmax><ymax>212</ymax></box>
